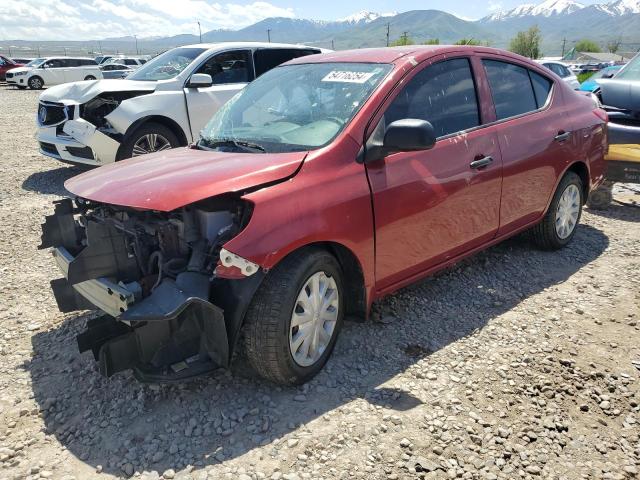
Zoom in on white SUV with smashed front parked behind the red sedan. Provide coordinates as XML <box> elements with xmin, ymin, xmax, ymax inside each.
<box><xmin>37</xmin><ymin>42</ymin><xmax>322</xmax><ymax>166</ymax></box>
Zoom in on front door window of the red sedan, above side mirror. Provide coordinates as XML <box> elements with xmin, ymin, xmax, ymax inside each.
<box><xmin>384</xmin><ymin>58</ymin><xmax>480</xmax><ymax>137</ymax></box>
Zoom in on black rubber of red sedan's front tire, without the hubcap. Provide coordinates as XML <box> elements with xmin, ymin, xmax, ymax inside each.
<box><xmin>244</xmin><ymin>248</ymin><xmax>344</xmax><ymax>385</ymax></box>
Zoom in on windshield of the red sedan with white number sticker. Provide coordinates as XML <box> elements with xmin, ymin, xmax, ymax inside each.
<box><xmin>198</xmin><ymin>63</ymin><xmax>392</xmax><ymax>152</ymax></box>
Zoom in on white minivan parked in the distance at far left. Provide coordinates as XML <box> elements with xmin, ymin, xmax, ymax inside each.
<box><xmin>7</xmin><ymin>57</ymin><xmax>102</xmax><ymax>90</ymax></box>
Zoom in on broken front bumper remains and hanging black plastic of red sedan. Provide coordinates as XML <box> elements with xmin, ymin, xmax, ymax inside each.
<box><xmin>40</xmin><ymin>199</ymin><xmax>262</xmax><ymax>382</ymax></box>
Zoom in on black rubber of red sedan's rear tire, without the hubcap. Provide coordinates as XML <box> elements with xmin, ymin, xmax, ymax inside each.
<box><xmin>530</xmin><ymin>172</ymin><xmax>584</xmax><ymax>250</ymax></box>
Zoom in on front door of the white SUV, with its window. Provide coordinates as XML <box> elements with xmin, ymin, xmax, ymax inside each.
<box><xmin>184</xmin><ymin>50</ymin><xmax>254</xmax><ymax>140</ymax></box>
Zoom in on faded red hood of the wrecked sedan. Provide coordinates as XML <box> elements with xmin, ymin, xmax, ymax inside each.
<box><xmin>64</xmin><ymin>148</ymin><xmax>307</xmax><ymax>212</ymax></box>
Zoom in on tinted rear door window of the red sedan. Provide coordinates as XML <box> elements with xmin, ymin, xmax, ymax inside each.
<box><xmin>482</xmin><ymin>60</ymin><xmax>538</xmax><ymax>120</ymax></box>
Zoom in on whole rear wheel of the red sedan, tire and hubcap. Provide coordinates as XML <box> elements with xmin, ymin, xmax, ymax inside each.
<box><xmin>531</xmin><ymin>172</ymin><xmax>584</xmax><ymax>250</ymax></box>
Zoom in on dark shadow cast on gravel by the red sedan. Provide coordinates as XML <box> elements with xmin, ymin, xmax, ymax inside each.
<box><xmin>24</xmin><ymin>225</ymin><xmax>609</xmax><ymax>475</ymax></box>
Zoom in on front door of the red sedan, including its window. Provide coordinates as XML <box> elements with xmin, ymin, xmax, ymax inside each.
<box><xmin>366</xmin><ymin>56</ymin><xmax>502</xmax><ymax>290</ymax></box>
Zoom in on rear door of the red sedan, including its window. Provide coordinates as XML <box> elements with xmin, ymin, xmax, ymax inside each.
<box><xmin>482</xmin><ymin>56</ymin><xmax>579</xmax><ymax>234</ymax></box>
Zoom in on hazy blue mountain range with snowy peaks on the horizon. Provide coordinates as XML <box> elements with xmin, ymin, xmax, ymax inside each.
<box><xmin>0</xmin><ymin>0</ymin><xmax>640</xmax><ymax>55</ymax></box>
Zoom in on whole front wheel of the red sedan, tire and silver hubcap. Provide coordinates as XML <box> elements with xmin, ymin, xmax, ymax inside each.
<box><xmin>244</xmin><ymin>249</ymin><xmax>344</xmax><ymax>385</ymax></box>
